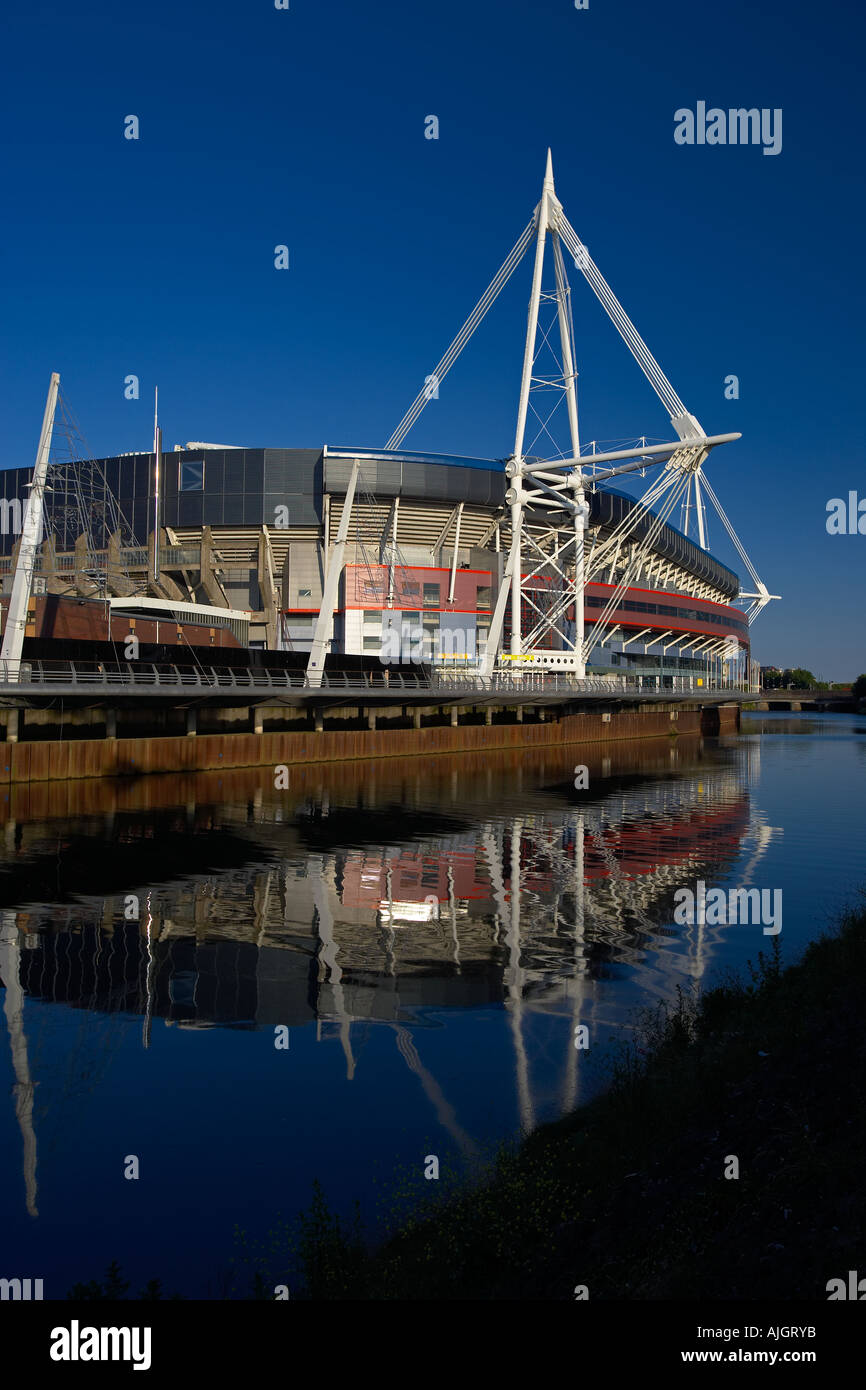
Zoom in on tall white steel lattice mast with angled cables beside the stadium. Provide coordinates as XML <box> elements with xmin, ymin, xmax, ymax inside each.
<box><xmin>372</xmin><ymin>152</ymin><xmax>778</xmax><ymax>677</ymax></box>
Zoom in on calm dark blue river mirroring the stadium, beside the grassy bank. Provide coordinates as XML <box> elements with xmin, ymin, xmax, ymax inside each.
<box><xmin>0</xmin><ymin>714</ymin><xmax>866</xmax><ymax>1298</ymax></box>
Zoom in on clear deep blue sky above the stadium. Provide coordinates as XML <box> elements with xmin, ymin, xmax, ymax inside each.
<box><xmin>0</xmin><ymin>0</ymin><xmax>866</xmax><ymax>680</ymax></box>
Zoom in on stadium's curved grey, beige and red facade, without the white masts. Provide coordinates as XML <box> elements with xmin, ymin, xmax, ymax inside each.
<box><xmin>0</xmin><ymin>445</ymin><xmax>749</xmax><ymax>685</ymax></box>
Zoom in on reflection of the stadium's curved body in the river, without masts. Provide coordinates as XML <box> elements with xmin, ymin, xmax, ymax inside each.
<box><xmin>6</xmin><ymin>746</ymin><xmax>778</xmax><ymax>1050</ymax></box>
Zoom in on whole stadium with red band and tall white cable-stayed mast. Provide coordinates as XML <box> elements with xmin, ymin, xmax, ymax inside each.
<box><xmin>0</xmin><ymin>154</ymin><xmax>776</xmax><ymax>689</ymax></box>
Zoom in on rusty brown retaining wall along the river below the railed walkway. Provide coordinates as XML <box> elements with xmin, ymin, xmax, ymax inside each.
<box><xmin>0</xmin><ymin>702</ymin><xmax>740</xmax><ymax>784</ymax></box>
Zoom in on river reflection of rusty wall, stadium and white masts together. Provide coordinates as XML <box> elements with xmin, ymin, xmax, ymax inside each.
<box><xmin>0</xmin><ymin>738</ymin><xmax>776</xmax><ymax>1215</ymax></box>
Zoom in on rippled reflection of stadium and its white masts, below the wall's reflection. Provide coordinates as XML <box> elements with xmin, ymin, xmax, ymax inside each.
<box><xmin>0</xmin><ymin>744</ymin><xmax>773</xmax><ymax>1207</ymax></box>
